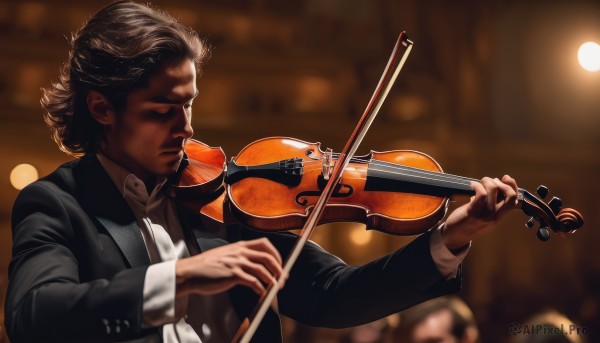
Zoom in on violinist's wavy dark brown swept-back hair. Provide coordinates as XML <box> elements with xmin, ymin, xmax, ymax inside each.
<box><xmin>40</xmin><ymin>1</ymin><xmax>208</xmax><ymax>156</ymax></box>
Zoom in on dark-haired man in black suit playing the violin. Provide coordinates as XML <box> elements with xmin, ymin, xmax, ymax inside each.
<box><xmin>5</xmin><ymin>1</ymin><xmax>517</xmax><ymax>343</ymax></box>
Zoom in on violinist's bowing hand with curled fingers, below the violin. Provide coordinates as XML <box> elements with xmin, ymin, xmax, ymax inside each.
<box><xmin>175</xmin><ymin>238</ymin><xmax>283</xmax><ymax>295</ymax></box>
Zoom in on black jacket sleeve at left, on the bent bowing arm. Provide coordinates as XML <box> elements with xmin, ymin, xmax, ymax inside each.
<box><xmin>5</xmin><ymin>181</ymin><xmax>156</xmax><ymax>343</ymax></box>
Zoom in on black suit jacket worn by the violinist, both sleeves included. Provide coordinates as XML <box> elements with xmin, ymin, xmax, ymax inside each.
<box><xmin>5</xmin><ymin>156</ymin><xmax>460</xmax><ymax>343</ymax></box>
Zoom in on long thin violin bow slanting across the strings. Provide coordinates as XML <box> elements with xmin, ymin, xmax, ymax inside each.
<box><xmin>232</xmin><ymin>31</ymin><xmax>413</xmax><ymax>343</ymax></box>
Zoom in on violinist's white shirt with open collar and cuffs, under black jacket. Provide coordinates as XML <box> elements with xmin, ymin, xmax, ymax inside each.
<box><xmin>97</xmin><ymin>154</ymin><xmax>468</xmax><ymax>343</ymax></box>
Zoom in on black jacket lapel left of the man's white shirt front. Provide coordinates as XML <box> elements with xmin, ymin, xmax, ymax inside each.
<box><xmin>74</xmin><ymin>155</ymin><xmax>150</xmax><ymax>268</ymax></box>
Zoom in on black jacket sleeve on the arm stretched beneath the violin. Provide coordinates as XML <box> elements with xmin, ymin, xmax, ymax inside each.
<box><xmin>251</xmin><ymin>227</ymin><xmax>461</xmax><ymax>328</ymax></box>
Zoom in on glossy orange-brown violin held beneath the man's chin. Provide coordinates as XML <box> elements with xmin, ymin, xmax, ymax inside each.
<box><xmin>173</xmin><ymin>137</ymin><xmax>583</xmax><ymax>241</ymax></box>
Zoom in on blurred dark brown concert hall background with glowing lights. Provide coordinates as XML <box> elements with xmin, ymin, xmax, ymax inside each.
<box><xmin>0</xmin><ymin>0</ymin><xmax>600</xmax><ymax>342</ymax></box>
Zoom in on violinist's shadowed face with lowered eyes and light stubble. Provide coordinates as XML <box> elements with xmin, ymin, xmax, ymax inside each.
<box><xmin>103</xmin><ymin>59</ymin><xmax>197</xmax><ymax>188</ymax></box>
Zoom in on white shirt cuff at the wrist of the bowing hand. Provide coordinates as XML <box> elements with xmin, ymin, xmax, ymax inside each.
<box><xmin>142</xmin><ymin>260</ymin><xmax>177</xmax><ymax>327</ymax></box>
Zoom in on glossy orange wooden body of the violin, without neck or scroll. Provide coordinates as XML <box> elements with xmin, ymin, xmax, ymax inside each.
<box><xmin>226</xmin><ymin>137</ymin><xmax>448</xmax><ymax>235</ymax></box>
